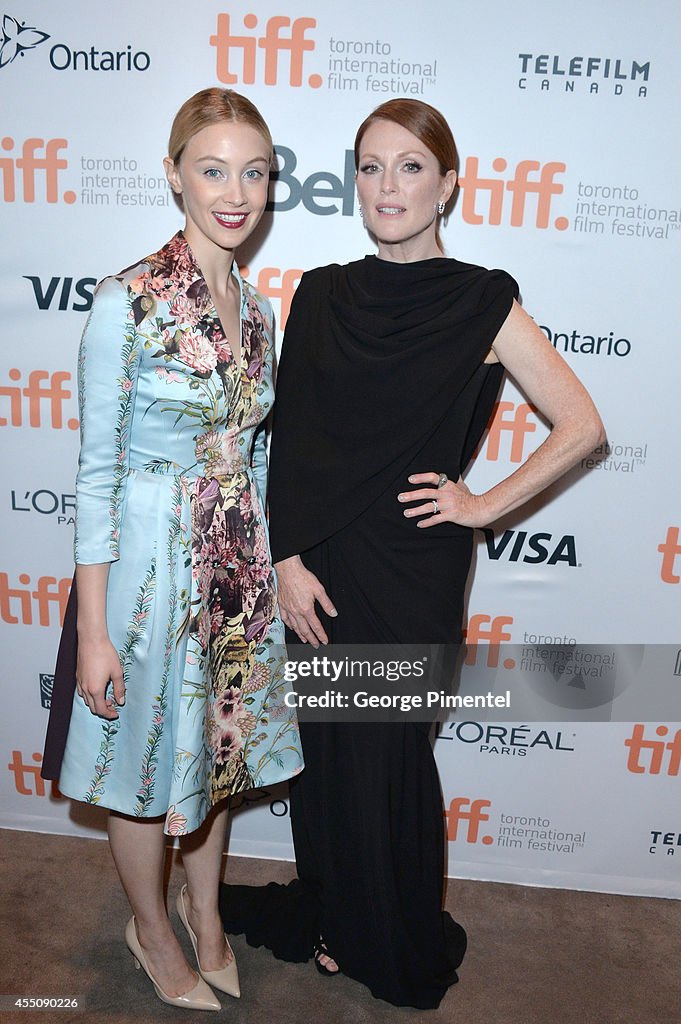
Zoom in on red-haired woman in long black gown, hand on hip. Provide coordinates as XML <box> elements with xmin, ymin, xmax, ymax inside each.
<box><xmin>222</xmin><ymin>99</ymin><xmax>603</xmax><ymax>1008</ymax></box>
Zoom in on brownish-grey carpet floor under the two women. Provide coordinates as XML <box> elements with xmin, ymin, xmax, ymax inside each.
<box><xmin>0</xmin><ymin>829</ymin><xmax>681</xmax><ymax>1024</ymax></box>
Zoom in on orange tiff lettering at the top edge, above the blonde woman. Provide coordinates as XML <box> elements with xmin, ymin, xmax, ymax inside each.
<box><xmin>210</xmin><ymin>14</ymin><xmax>324</xmax><ymax>89</ymax></box>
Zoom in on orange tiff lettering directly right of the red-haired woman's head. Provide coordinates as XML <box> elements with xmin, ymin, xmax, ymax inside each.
<box><xmin>459</xmin><ymin>157</ymin><xmax>569</xmax><ymax>231</ymax></box>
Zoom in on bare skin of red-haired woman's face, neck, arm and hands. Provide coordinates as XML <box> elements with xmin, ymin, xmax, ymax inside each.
<box><xmin>275</xmin><ymin>120</ymin><xmax>605</xmax><ymax>648</ymax></box>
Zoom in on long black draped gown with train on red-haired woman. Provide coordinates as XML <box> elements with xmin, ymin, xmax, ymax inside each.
<box><xmin>222</xmin><ymin>257</ymin><xmax>517</xmax><ymax>1009</ymax></box>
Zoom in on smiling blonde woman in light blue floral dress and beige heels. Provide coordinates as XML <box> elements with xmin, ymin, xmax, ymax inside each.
<box><xmin>45</xmin><ymin>89</ymin><xmax>302</xmax><ymax>1010</ymax></box>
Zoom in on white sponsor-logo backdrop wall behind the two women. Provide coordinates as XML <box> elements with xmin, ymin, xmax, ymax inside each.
<box><xmin>0</xmin><ymin>0</ymin><xmax>681</xmax><ymax>897</ymax></box>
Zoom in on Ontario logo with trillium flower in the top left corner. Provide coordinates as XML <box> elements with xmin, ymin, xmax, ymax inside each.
<box><xmin>0</xmin><ymin>14</ymin><xmax>152</xmax><ymax>72</ymax></box>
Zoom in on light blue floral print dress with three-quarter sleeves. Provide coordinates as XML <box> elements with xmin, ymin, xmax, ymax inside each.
<box><xmin>59</xmin><ymin>232</ymin><xmax>302</xmax><ymax>835</ymax></box>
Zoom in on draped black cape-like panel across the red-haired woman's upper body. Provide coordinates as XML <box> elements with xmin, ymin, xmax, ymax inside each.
<box><xmin>269</xmin><ymin>256</ymin><xmax>517</xmax><ymax>561</ymax></box>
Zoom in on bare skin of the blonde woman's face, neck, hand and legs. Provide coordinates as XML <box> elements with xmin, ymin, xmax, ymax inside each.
<box><xmin>76</xmin><ymin>116</ymin><xmax>271</xmax><ymax>996</ymax></box>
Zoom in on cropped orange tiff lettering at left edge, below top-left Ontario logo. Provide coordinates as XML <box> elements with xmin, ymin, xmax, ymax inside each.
<box><xmin>0</xmin><ymin>135</ymin><xmax>77</xmax><ymax>204</ymax></box>
